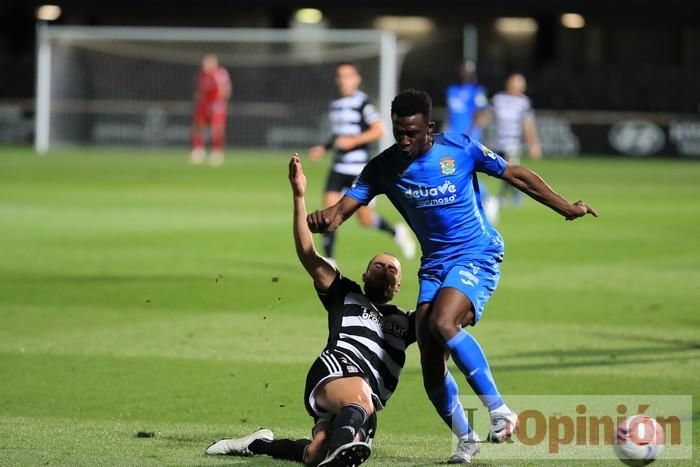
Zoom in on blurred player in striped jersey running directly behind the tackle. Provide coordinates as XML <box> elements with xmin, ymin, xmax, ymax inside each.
<box><xmin>308</xmin><ymin>62</ymin><xmax>416</xmax><ymax>264</ymax></box>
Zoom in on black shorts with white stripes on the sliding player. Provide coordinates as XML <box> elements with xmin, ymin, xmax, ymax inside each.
<box><xmin>304</xmin><ymin>349</ymin><xmax>381</xmax><ymax>444</ymax></box>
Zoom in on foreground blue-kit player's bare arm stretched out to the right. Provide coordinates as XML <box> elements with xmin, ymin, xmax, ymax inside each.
<box><xmin>501</xmin><ymin>165</ymin><xmax>598</xmax><ymax>221</ymax></box>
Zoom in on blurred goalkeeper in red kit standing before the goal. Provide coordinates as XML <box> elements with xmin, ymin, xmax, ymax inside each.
<box><xmin>190</xmin><ymin>54</ymin><xmax>231</xmax><ymax>166</ymax></box>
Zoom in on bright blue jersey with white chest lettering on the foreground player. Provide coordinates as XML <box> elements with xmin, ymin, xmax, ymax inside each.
<box><xmin>346</xmin><ymin>132</ymin><xmax>506</xmax><ymax>273</ymax></box>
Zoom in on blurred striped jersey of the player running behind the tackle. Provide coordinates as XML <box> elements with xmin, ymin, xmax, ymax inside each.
<box><xmin>328</xmin><ymin>91</ymin><xmax>381</xmax><ymax>175</ymax></box>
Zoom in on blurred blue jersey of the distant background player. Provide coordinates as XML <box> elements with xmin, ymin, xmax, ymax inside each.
<box><xmin>447</xmin><ymin>83</ymin><xmax>489</xmax><ymax>139</ymax></box>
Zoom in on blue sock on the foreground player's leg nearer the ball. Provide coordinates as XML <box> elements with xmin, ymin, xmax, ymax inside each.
<box><xmin>446</xmin><ymin>331</ymin><xmax>503</xmax><ymax>410</ymax></box>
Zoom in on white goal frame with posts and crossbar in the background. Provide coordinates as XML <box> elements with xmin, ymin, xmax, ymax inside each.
<box><xmin>34</xmin><ymin>23</ymin><xmax>398</xmax><ymax>154</ymax></box>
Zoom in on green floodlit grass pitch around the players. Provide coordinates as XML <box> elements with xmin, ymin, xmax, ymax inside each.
<box><xmin>0</xmin><ymin>148</ymin><xmax>700</xmax><ymax>466</ymax></box>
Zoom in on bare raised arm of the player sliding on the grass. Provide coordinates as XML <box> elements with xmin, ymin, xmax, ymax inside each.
<box><xmin>289</xmin><ymin>154</ymin><xmax>338</xmax><ymax>291</ymax></box>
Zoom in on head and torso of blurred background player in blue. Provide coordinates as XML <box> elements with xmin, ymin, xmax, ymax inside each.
<box><xmin>446</xmin><ymin>60</ymin><xmax>489</xmax><ymax>140</ymax></box>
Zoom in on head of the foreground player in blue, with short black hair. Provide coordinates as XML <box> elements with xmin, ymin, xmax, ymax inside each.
<box><xmin>391</xmin><ymin>89</ymin><xmax>435</xmax><ymax>158</ymax></box>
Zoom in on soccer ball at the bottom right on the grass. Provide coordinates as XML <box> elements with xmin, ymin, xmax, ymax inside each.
<box><xmin>614</xmin><ymin>415</ymin><xmax>666</xmax><ymax>466</ymax></box>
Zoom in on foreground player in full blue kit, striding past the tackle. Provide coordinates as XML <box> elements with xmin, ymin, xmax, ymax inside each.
<box><xmin>307</xmin><ymin>90</ymin><xmax>597</xmax><ymax>463</ymax></box>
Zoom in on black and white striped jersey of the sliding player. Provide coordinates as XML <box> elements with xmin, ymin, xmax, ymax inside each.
<box><xmin>317</xmin><ymin>274</ymin><xmax>416</xmax><ymax>409</ymax></box>
